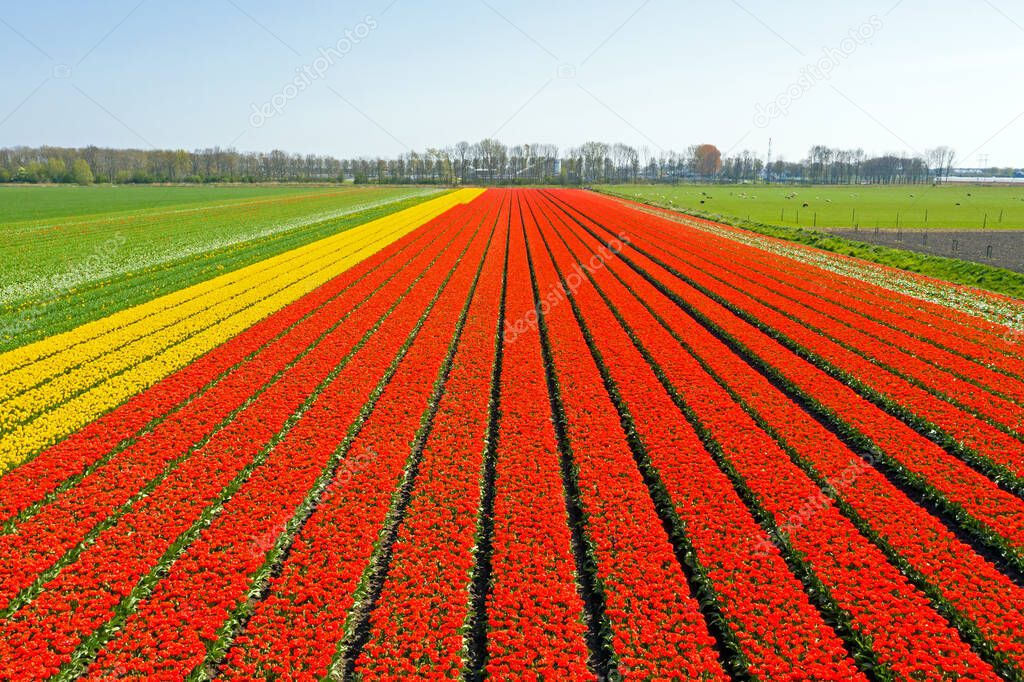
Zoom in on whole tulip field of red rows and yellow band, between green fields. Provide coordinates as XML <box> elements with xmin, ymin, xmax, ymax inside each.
<box><xmin>0</xmin><ymin>183</ymin><xmax>1024</xmax><ymax>681</ymax></box>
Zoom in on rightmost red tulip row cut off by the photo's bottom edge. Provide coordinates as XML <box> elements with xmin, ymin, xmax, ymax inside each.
<box><xmin>540</xmin><ymin>188</ymin><xmax>996</xmax><ymax>679</ymax></box>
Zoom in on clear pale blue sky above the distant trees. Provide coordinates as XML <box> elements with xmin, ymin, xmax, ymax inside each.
<box><xmin>0</xmin><ymin>0</ymin><xmax>1024</xmax><ymax>166</ymax></box>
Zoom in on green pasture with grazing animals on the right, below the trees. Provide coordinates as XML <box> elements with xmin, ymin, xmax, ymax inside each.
<box><xmin>596</xmin><ymin>184</ymin><xmax>1024</xmax><ymax>229</ymax></box>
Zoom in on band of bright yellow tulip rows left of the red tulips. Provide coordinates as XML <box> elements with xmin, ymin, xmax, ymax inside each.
<box><xmin>0</xmin><ymin>189</ymin><xmax>479</xmax><ymax>473</ymax></box>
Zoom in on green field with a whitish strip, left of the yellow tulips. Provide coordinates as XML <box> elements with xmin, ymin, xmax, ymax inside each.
<box><xmin>0</xmin><ymin>185</ymin><xmax>436</xmax><ymax>350</ymax></box>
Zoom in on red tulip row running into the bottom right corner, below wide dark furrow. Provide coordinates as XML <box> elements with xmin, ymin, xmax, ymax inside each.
<box><xmin>544</xmin><ymin>188</ymin><xmax>1024</xmax><ymax>670</ymax></box>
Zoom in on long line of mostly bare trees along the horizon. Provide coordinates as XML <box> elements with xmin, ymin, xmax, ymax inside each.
<box><xmin>0</xmin><ymin>139</ymin><xmax>994</xmax><ymax>185</ymax></box>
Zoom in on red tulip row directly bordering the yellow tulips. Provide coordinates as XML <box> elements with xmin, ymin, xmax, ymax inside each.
<box><xmin>0</xmin><ymin>207</ymin><xmax>440</xmax><ymax>522</ymax></box>
